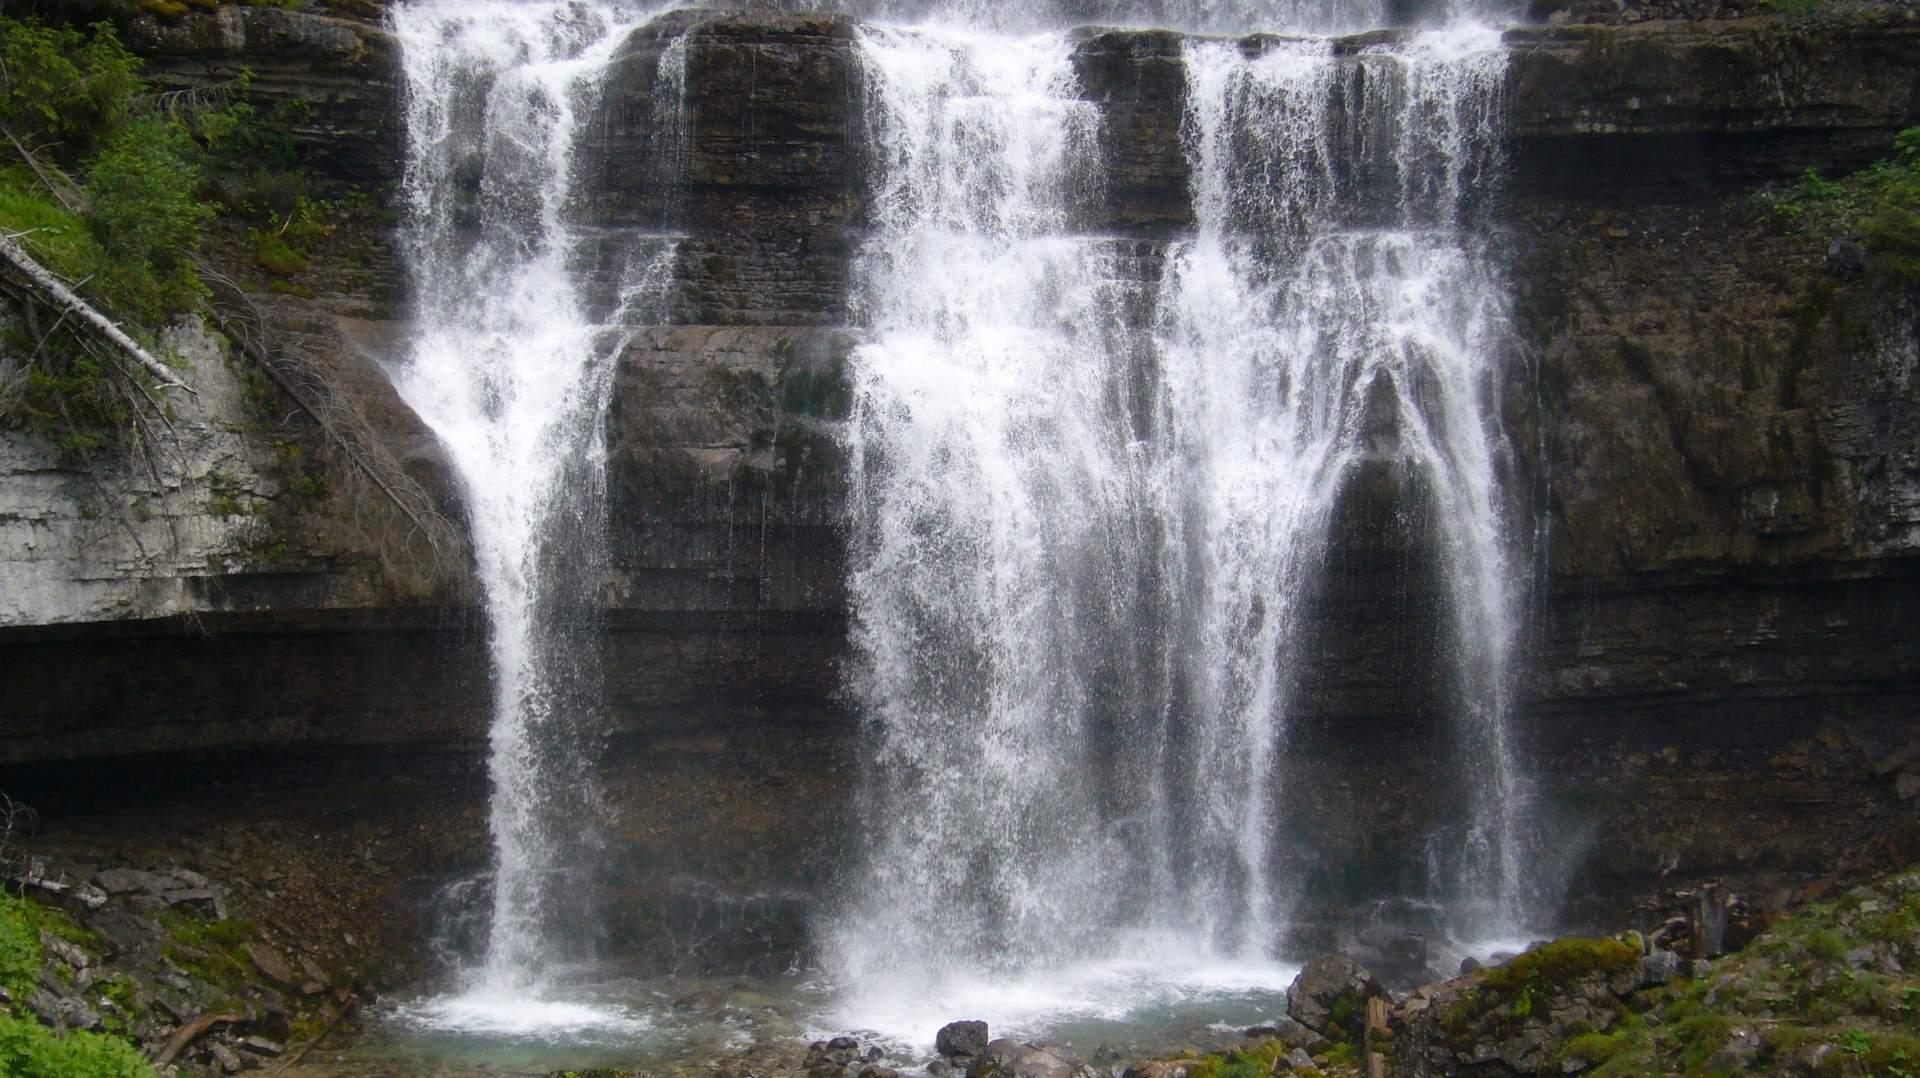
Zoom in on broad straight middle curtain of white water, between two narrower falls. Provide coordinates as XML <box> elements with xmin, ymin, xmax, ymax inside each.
<box><xmin>821</xmin><ymin>29</ymin><xmax>1137</xmax><ymax>974</ymax></box>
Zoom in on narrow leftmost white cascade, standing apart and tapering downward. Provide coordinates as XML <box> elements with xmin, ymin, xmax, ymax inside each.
<box><xmin>392</xmin><ymin>0</ymin><xmax>670</xmax><ymax>1018</ymax></box>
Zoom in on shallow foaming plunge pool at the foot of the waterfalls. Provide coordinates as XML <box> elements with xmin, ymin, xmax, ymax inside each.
<box><xmin>291</xmin><ymin>955</ymin><xmax>1298</xmax><ymax>1078</ymax></box>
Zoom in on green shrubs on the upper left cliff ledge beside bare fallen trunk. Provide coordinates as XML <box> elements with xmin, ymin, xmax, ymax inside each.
<box><xmin>0</xmin><ymin>13</ymin><xmax>326</xmax><ymax>455</ymax></box>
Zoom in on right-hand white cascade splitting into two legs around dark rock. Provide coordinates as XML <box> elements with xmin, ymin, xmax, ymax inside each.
<box><xmin>1162</xmin><ymin>29</ymin><xmax>1519</xmax><ymax>932</ymax></box>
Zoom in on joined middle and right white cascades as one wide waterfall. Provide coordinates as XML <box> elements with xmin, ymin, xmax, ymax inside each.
<box><xmin>826</xmin><ymin>10</ymin><xmax>1523</xmax><ymax>1030</ymax></box>
